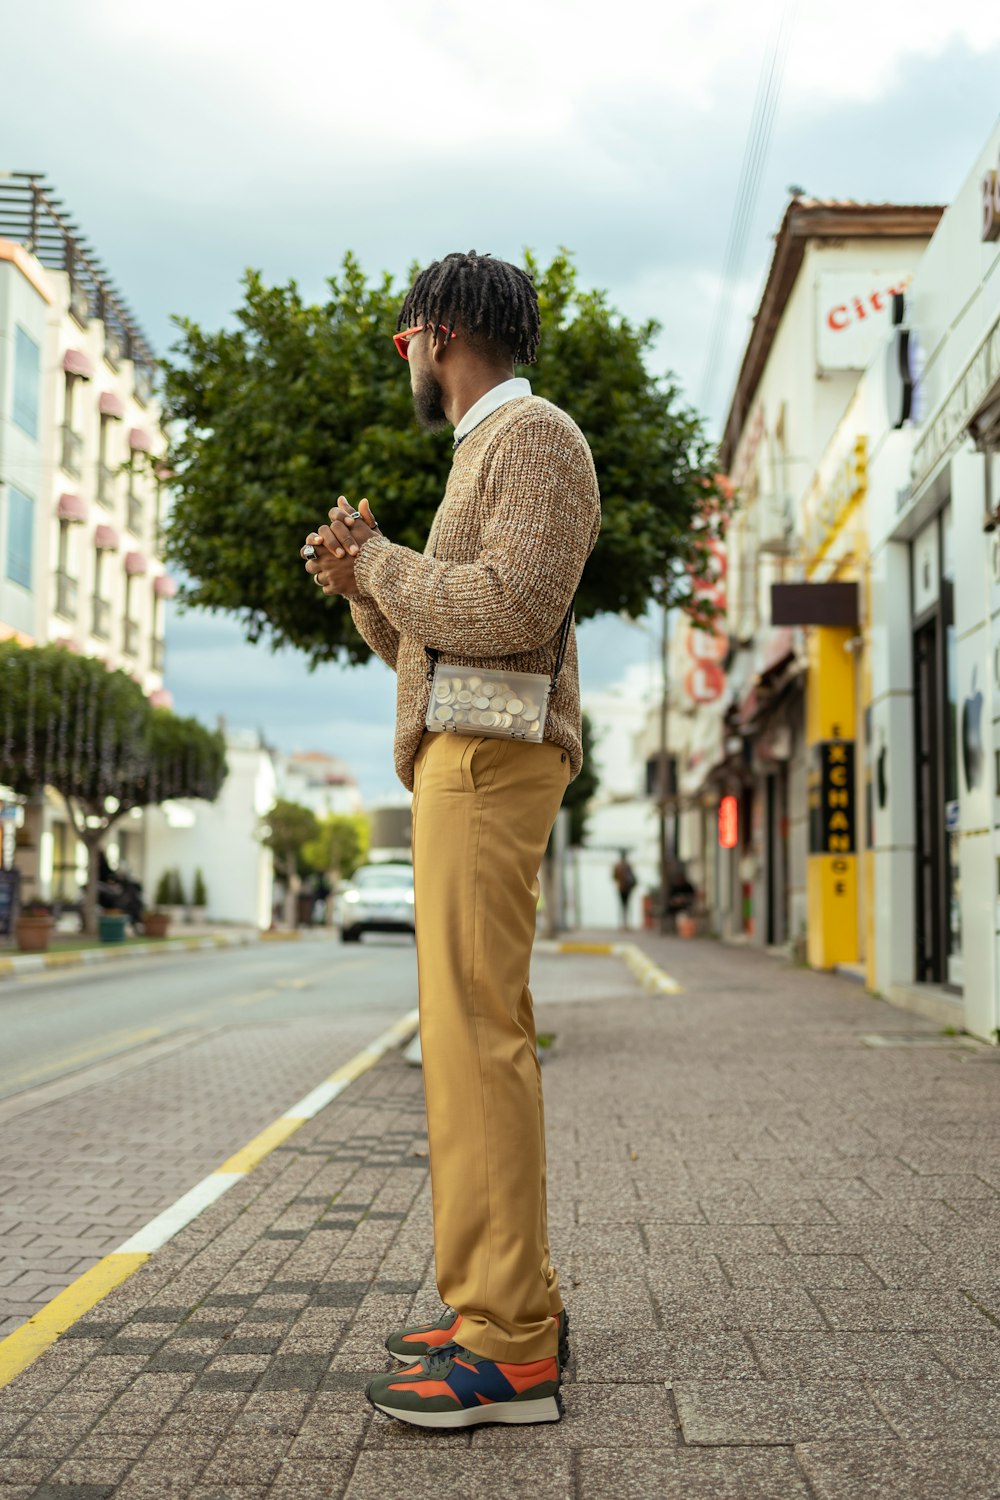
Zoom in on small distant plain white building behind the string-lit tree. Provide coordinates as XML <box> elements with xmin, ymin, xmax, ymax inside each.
<box><xmin>144</xmin><ymin>731</ymin><xmax>277</xmax><ymax>927</ymax></box>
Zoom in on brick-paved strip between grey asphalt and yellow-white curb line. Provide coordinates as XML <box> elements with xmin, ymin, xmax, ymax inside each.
<box><xmin>0</xmin><ymin>1014</ymin><xmax>413</xmax><ymax>1338</ymax></box>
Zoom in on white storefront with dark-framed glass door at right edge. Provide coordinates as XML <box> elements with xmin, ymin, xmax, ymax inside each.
<box><xmin>867</xmin><ymin>126</ymin><xmax>1000</xmax><ymax>1041</ymax></box>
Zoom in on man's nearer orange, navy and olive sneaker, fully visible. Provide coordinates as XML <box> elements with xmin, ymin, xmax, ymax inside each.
<box><xmin>366</xmin><ymin>1344</ymin><xmax>562</xmax><ymax>1428</ymax></box>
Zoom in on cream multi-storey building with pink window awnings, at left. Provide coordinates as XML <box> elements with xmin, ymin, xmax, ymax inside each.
<box><xmin>0</xmin><ymin>174</ymin><xmax>174</xmax><ymax>899</ymax></box>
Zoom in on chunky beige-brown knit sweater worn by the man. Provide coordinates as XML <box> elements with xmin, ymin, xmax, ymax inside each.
<box><xmin>351</xmin><ymin>396</ymin><xmax>601</xmax><ymax>789</ymax></box>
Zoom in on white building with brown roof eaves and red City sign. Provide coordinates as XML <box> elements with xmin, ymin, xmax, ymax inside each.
<box><xmin>670</xmin><ymin>198</ymin><xmax>942</xmax><ymax>965</ymax></box>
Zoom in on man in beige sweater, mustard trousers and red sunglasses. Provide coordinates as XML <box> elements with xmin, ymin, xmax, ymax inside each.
<box><xmin>306</xmin><ymin>252</ymin><xmax>600</xmax><ymax>1428</ymax></box>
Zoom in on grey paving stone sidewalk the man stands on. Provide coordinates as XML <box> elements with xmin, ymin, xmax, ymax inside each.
<box><xmin>0</xmin><ymin>938</ymin><xmax>1000</xmax><ymax>1500</ymax></box>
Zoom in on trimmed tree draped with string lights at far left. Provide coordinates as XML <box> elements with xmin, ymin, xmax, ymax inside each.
<box><xmin>0</xmin><ymin>641</ymin><xmax>226</xmax><ymax>933</ymax></box>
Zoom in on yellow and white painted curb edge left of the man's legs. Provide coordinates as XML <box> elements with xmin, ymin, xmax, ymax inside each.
<box><xmin>0</xmin><ymin>1011</ymin><xmax>418</xmax><ymax>1388</ymax></box>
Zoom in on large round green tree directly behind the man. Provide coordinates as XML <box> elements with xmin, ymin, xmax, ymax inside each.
<box><xmin>165</xmin><ymin>252</ymin><xmax>727</xmax><ymax>665</ymax></box>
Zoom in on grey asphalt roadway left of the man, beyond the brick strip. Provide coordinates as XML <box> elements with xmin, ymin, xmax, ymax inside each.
<box><xmin>0</xmin><ymin>938</ymin><xmax>417</xmax><ymax>1100</ymax></box>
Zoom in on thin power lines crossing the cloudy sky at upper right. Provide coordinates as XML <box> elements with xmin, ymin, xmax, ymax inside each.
<box><xmin>700</xmin><ymin>0</ymin><xmax>795</xmax><ymax>429</ymax></box>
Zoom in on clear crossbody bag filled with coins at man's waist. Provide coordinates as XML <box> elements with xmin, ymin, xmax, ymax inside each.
<box><xmin>424</xmin><ymin>605</ymin><xmax>573</xmax><ymax>744</ymax></box>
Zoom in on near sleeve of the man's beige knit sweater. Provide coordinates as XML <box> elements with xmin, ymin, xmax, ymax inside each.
<box><xmin>355</xmin><ymin>417</ymin><xmax>600</xmax><ymax>657</ymax></box>
